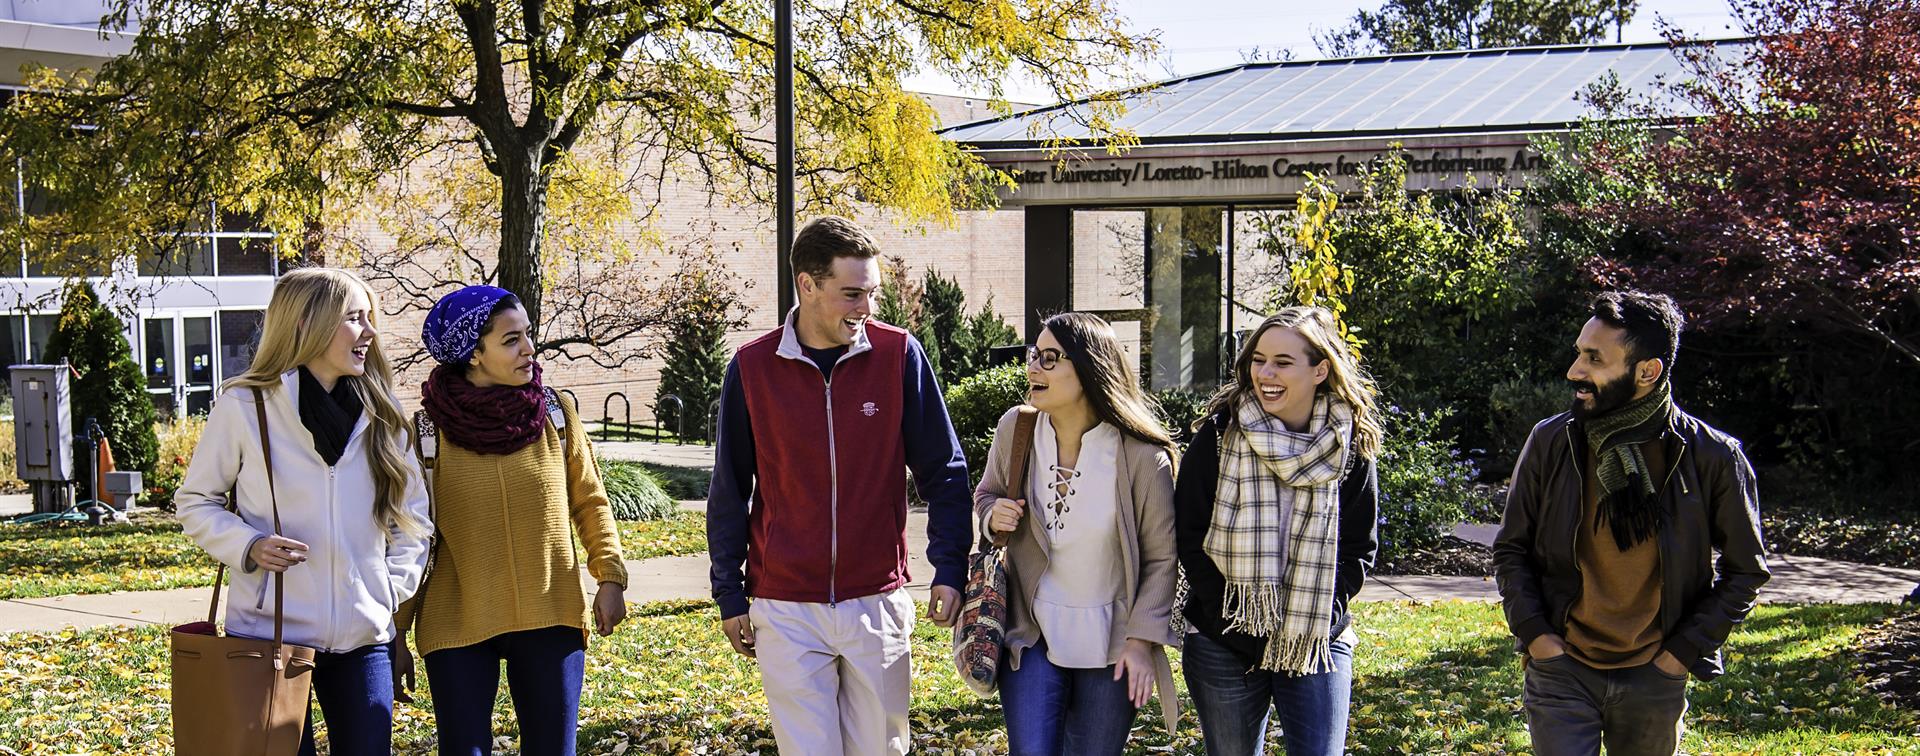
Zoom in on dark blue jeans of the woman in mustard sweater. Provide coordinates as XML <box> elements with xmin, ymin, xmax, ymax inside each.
<box><xmin>426</xmin><ymin>626</ymin><xmax>588</xmax><ymax>756</ymax></box>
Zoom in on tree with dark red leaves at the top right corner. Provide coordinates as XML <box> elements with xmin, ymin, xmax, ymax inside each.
<box><xmin>1578</xmin><ymin>0</ymin><xmax>1920</xmax><ymax>368</ymax></box>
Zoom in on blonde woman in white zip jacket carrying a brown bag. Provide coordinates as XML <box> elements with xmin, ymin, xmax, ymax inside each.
<box><xmin>173</xmin><ymin>269</ymin><xmax>432</xmax><ymax>754</ymax></box>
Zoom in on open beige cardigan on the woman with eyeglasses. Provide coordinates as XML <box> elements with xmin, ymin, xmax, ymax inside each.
<box><xmin>973</xmin><ymin>407</ymin><xmax>1181</xmax><ymax>727</ymax></box>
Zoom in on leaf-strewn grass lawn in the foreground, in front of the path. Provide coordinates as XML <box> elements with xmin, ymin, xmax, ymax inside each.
<box><xmin>0</xmin><ymin>602</ymin><xmax>1920</xmax><ymax>754</ymax></box>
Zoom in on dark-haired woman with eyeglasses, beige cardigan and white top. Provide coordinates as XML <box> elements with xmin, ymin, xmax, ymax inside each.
<box><xmin>973</xmin><ymin>313</ymin><xmax>1179</xmax><ymax>754</ymax></box>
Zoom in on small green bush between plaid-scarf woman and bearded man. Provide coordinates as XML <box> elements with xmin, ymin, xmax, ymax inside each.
<box><xmin>1379</xmin><ymin>407</ymin><xmax>1486</xmax><ymax>560</ymax></box>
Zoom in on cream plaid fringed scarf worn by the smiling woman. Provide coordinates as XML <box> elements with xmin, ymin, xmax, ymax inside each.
<box><xmin>1204</xmin><ymin>395</ymin><xmax>1354</xmax><ymax>675</ymax></box>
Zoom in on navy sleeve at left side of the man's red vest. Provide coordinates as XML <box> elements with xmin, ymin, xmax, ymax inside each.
<box><xmin>707</xmin><ymin>357</ymin><xmax>752</xmax><ymax>620</ymax></box>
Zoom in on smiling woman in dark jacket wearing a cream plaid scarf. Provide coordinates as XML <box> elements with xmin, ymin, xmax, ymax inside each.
<box><xmin>1173</xmin><ymin>307</ymin><xmax>1380</xmax><ymax>756</ymax></box>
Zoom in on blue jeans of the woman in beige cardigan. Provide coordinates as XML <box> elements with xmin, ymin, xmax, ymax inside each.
<box><xmin>1000</xmin><ymin>639</ymin><xmax>1133</xmax><ymax>756</ymax></box>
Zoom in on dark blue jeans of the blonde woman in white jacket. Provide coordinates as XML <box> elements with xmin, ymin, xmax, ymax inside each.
<box><xmin>300</xmin><ymin>643</ymin><xmax>394</xmax><ymax>756</ymax></box>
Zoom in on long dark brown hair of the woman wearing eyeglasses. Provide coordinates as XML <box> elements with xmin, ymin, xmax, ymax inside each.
<box><xmin>1044</xmin><ymin>313</ymin><xmax>1175</xmax><ymax>455</ymax></box>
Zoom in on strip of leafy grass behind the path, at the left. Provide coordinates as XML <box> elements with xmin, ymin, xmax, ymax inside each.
<box><xmin>0</xmin><ymin>512</ymin><xmax>707</xmax><ymax>599</ymax></box>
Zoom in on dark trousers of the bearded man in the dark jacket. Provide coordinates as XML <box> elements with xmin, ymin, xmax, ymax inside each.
<box><xmin>1523</xmin><ymin>654</ymin><xmax>1686</xmax><ymax>756</ymax></box>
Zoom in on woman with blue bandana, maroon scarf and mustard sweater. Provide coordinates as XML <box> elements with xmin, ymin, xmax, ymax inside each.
<box><xmin>394</xmin><ymin>286</ymin><xmax>626</xmax><ymax>756</ymax></box>
